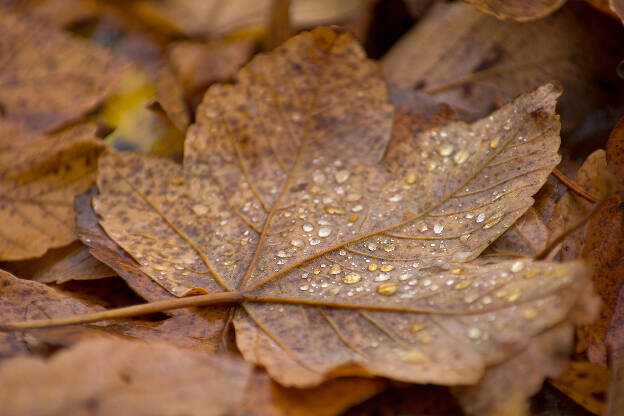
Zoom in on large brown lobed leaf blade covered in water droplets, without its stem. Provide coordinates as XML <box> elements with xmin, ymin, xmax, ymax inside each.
<box><xmin>83</xmin><ymin>28</ymin><xmax>591</xmax><ymax>412</ymax></box>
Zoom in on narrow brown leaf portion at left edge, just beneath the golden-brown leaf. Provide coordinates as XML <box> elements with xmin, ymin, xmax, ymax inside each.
<box><xmin>2</xmin><ymin>242</ymin><xmax>116</xmax><ymax>284</ymax></box>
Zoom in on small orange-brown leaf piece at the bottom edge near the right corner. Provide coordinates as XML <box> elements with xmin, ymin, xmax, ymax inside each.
<box><xmin>550</xmin><ymin>361</ymin><xmax>609</xmax><ymax>415</ymax></box>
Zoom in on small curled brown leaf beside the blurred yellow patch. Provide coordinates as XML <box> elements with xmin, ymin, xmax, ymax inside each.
<box><xmin>148</xmin><ymin>66</ymin><xmax>189</xmax><ymax>132</ymax></box>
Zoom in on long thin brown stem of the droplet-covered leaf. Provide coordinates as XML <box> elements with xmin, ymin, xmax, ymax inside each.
<box><xmin>0</xmin><ymin>291</ymin><xmax>243</xmax><ymax>331</ymax></box>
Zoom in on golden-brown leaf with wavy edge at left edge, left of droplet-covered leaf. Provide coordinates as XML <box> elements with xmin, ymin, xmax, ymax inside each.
<box><xmin>0</xmin><ymin>122</ymin><xmax>103</xmax><ymax>260</ymax></box>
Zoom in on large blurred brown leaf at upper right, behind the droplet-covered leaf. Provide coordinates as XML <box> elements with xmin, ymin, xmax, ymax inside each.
<box><xmin>382</xmin><ymin>1</ymin><xmax>624</xmax><ymax>138</ymax></box>
